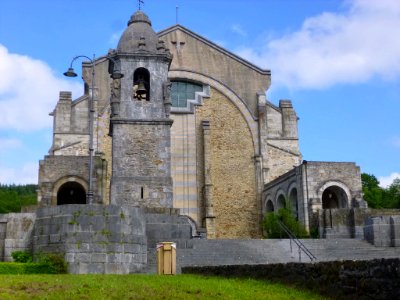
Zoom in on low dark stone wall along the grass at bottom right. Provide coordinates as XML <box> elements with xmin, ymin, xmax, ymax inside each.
<box><xmin>182</xmin><ymin>259</ymin><xmax>400</xmax><ymax>299</ymax></box>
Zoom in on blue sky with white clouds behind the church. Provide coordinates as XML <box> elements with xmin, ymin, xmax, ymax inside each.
<box><xmin>0</xmin><ymin>0</ymin><xmax>400</xmax><ymax>186</ymax></box>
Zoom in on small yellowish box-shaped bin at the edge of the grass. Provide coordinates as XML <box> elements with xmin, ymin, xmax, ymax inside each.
<box><xmin>157</xmin><ymin>242</ymin><xmax>176</xmax><ymax>275</ymax></box>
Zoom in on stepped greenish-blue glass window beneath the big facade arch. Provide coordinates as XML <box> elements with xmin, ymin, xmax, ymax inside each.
<box><xmin>171</xmin><ymin>81</ymin><xmax>203</xmax><ymax>107</ymax></box>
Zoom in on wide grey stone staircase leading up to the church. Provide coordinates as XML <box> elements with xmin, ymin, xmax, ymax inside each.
<box><xmin>146</xmin><ymin>239</ymin><xmax>400</xmax><ymax>273</ymax></box>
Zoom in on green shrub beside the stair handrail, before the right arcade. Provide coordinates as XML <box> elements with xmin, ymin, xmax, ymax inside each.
<box><xmin>262</xmin><ymin>208</ymin><xmax>309</xmax><ymax>239</ymax></box>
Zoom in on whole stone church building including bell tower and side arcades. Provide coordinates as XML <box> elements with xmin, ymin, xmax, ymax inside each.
<box><xmin>39</xmin><ymin>11</ymin><xmax>364</xmax><ymax>239</ymax></box>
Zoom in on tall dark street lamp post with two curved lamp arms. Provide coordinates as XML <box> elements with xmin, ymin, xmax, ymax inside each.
<box><xmin>64</xmin><ymin>55</ymin><xmax>124</xmax><ymax>204</ymax></box>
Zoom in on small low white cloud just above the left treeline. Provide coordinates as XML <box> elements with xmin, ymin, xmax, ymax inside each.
<box><xmin>0</xmin><ymin>162</ymin><xmax>39</xmax><ymax>184</ymax></box>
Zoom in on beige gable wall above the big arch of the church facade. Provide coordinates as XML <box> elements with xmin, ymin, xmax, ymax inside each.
<box><xmin>158</xmin><ymin>26</ymin><xmax>271</xmax><ymax>116</ymax></box>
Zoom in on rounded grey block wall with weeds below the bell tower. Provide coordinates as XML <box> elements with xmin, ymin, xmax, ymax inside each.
<box><xmin>33</xmin><ymin>205</ymin><xmax>147</xmax><ymax>274</ymax></box>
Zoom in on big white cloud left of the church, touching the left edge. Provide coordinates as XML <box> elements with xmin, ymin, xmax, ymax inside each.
<box><xmin>0</xmin><ymin>44</ymin><xmax>82</xmax><ymax>131</ymax></box>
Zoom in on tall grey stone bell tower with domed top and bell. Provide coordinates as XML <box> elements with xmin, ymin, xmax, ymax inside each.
<box><xmin>110</xmin><ymin>11</ymin><xmax>173</xmax><ymax>208</ymax></box>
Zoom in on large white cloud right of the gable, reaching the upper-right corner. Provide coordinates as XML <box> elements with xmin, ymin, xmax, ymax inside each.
<box><xmin>237</xmin><ymin>0</ymin><xmax>400</xmax><ymax>89</ymax></box>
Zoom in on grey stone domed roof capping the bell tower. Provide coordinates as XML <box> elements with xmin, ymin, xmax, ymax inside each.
<box><xmin>117</xmin><ymin>10</ymin><xmax>158</xmax><ymax>53</ymax></box>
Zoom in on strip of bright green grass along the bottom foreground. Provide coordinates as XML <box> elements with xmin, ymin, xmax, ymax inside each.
<box><xmin>0</xmin><ymin>275</ymin><xmax>323</xmax><ymax>300</ymax></box>
